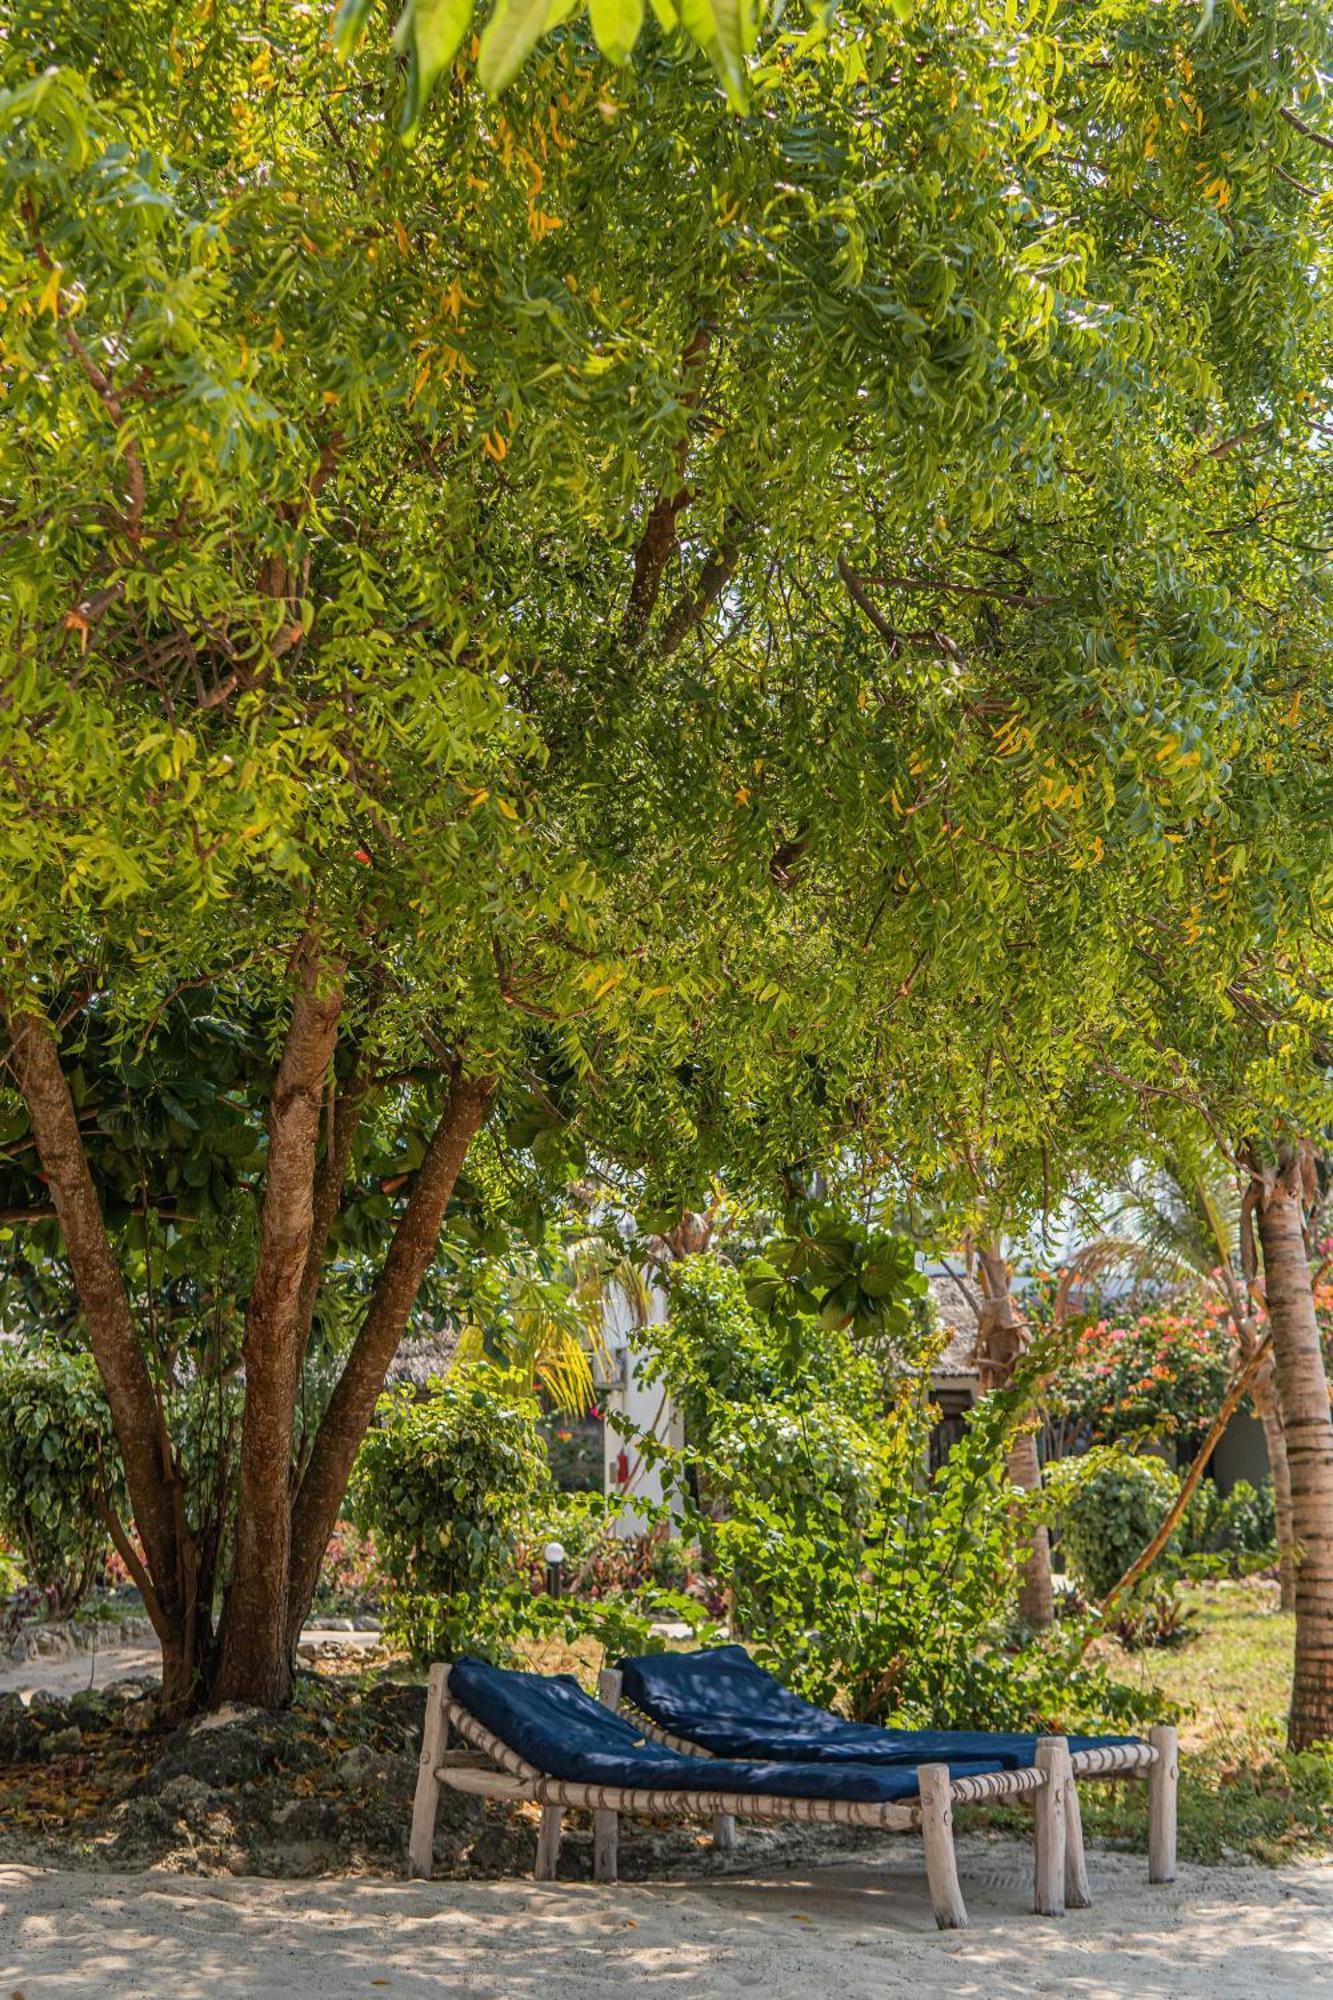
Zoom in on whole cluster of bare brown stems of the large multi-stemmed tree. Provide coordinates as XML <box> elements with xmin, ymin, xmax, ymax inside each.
<box><xmin>10</xmin><ymin>984</ymin><xmax>494</xmax><ymax>1718</ymax></box>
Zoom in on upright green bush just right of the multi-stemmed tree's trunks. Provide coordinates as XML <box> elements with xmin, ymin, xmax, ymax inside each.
<box><xmin>350</xmin><ymin>1366</ymin><xmax>550</xmax><ymax>1664</ymax></box>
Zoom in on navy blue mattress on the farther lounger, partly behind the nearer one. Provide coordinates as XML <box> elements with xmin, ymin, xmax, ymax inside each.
<box><xmin>620</xmin><ymin>1646</ymin><xmax>1137</xmax><ymax>1770</ymax></box>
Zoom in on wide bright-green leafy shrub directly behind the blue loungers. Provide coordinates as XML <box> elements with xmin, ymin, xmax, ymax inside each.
<box><xmin>668</xmin><ymin>1374</ymin><xmax>1137</xmax><ymax>1730</ymax></box>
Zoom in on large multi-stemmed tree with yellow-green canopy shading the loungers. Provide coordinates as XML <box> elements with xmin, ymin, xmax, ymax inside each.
<box><xmin>0</xmin><ymin>0</ymin><xmax>1321</xmax><ymax>1708</ymax></box>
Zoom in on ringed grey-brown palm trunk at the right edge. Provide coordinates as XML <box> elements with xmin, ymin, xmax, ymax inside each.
<box><xmin>1251</xmin><ymin>1148</ymin><xmax>1333</xmax><ymax>1750</ymax></box>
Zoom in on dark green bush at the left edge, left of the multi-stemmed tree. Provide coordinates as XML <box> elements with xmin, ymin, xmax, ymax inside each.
<box><xmin>0</xmin><ymin>1346</ymin><xmax>124</xmax><ymax>1618</ymax></box>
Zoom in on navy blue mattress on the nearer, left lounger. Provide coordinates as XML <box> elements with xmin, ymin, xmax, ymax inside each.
<box><xmin>448</xmin><ymin>1658</ymin><xmax>1003</xmax><ymax>1804</ymax></box>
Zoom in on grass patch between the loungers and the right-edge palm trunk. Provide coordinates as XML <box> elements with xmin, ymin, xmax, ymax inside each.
<box><xmin>1081</xmin><ymin>1578</ymin><xmax>1333</xmax><ymax>1862</ymax></box>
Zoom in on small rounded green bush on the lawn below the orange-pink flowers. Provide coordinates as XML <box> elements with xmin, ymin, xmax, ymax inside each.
<box><xmin>1047</xmin><ymin>1450</ymin><xmax>1181</xmax><ymax>1604</ymax></box>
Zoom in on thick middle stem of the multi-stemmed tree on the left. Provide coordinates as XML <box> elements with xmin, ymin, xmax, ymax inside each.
<box><xmin>218</xmin><ymin>938</ymin><xmax>342</xmax><ymax>1708</ymax></box>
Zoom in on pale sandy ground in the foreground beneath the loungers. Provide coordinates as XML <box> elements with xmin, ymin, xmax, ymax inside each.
<box><xmin>0</xmin><ymin>1838</ymin><xmax>1333</xmax><ymax>2000</ymax></box>
